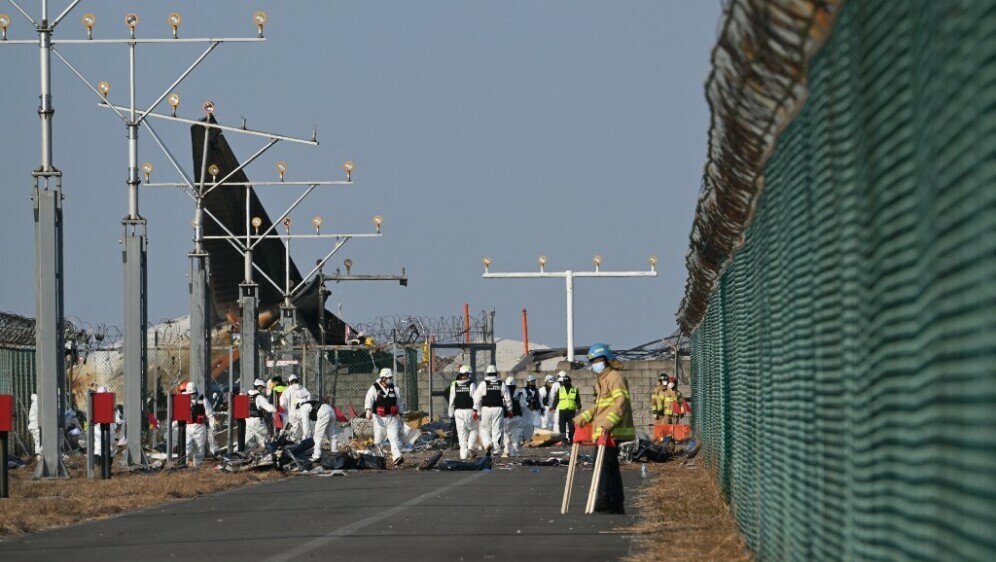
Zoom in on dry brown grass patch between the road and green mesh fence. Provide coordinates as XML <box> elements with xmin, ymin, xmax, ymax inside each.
<box><xmin>625</xmin><ymin>460</ymin><xmax>754</xmax><ymax>562</ymax></box>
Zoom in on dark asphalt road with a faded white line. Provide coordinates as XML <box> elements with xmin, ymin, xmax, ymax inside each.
<box><xmin>0</xmin><ymin>452</ymin><xmax>642</xmax><ymax>562</ymax></box>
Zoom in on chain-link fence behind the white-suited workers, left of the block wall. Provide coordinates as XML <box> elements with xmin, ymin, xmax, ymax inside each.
<box><xmin>0</xmin><ymin>306</ymin><xmax>493</xmax><ymax>454</ymax></box>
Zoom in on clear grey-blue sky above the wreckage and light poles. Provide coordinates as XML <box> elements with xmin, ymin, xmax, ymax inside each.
<box><xmin>0</xmin><ymin>0</ymin><xmax>721</xmax><ymax>347</ymax></box>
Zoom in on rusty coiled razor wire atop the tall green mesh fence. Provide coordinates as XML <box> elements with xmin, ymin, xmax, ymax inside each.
<box><xmin>677</xmin><ymin>0</ymin><xmax>841</xmax><ymax>335</ymax></box>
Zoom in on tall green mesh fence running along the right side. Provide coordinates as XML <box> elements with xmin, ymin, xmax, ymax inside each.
<box><xmin>691</xmin><ymin>0</ymin><xmax>996</xmax><ymax>560</ymax></box>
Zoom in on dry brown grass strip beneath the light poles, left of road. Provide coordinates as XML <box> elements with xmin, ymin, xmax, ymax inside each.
<box><xmin>0</xmin><ymin>463</ymin><xmax>283</xmax><ymax>537</ymax></box>
